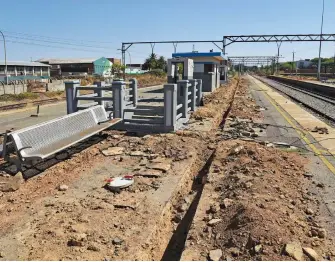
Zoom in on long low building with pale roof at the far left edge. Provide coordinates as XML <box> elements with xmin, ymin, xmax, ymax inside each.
<box><xmin>0</xmin><ymin>61</ymin><xmax>50</xmax><ymax>80</ymax></box>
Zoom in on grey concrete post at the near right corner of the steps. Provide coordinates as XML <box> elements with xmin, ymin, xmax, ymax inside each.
<box><xmin>164</xmin><ymin>84</ymin><xmax>177</xmax><ymax>130</ymax></box>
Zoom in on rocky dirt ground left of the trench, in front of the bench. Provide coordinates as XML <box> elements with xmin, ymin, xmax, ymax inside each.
<box><xmin>0</xmin><ymin>78</ymin><xmax>236</xmax><ymax>260</ymax></box>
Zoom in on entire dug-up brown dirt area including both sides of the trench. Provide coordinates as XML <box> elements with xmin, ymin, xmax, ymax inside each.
<box><xmin>0</xmin><ymin>75</ymin><xmax>335</xmax><ymax>260</ymax></box>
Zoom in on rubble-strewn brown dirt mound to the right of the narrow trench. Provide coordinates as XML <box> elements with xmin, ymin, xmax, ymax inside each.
<box><xmin>182</xmin><ymin>75</ymin><xmax>335</xmax><ymax>260</ymax></box>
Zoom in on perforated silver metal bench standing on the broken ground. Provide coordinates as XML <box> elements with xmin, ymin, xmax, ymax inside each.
<box><xmin>3</xmin><ymin>105</ymin><xmax>121</xmax><ymax>170</ymax></box>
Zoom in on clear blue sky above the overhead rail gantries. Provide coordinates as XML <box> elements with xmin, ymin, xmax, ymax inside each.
<box><xmin>0</xmin><ymin>0</ymin><xmax>335</xmax><ymax>63</ymax></box>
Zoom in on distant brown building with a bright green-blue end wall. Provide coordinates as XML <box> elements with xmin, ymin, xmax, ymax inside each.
<box><xmin>37</xmin><ymin>57</ymin><xmax>120</xmax><ymax>76</ymax></box>
